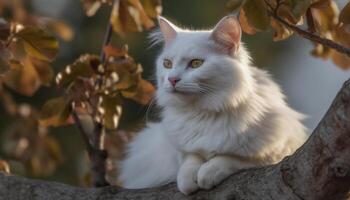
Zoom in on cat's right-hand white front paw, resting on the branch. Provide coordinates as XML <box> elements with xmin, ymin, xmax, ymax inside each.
<box><xmin>197</xmin><ymin>162</ymin><xmax>228</xmax><ymax>190</ymax></box>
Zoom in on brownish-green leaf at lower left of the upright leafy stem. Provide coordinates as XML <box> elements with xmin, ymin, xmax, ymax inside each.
<box><xmin>39</xmin><ymin>97</ymin><xmax>72</xmax><ymax>126</ymax></box>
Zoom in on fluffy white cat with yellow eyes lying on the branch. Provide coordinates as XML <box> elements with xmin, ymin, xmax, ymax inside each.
<box><xmin>120</xmin><ymin>16</ymin><xmax>307</xmax><ymax>194</ymax></box>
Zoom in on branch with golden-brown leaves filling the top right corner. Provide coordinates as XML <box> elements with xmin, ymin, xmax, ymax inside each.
<box><xmin>227</xmin><ymin>0</ymin><xmax>350</xmax><ymax>69</ymax></box>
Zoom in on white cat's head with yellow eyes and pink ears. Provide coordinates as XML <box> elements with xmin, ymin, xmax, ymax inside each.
<box><xmin>151</xmin><ymin>16</ymin><xmax>252</xmax><ymax>111</ymax></box>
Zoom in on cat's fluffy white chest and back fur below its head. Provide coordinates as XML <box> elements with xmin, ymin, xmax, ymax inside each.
<box><xmin>161</xmin><ymin>68</ymin><xmax>306</xmax><ymax>163</ymax></box>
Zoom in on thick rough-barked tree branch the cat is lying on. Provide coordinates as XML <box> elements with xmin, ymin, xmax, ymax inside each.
<box><xmin>0</xmin><ymin>80</ymin><xmax>350</xmax><ymax>200</ymax></box>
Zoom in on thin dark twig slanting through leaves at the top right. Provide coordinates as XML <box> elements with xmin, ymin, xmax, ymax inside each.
<box><xmin>265</xmin><ymin>1</ymin><xmax>350</xmax><ymax>57</ymax></box>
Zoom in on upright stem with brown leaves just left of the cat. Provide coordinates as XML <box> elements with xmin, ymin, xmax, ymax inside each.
<box><xmin>41</xmin><ymin>0</ymin><xmax>159</xmax><ymax>187</ymax></box>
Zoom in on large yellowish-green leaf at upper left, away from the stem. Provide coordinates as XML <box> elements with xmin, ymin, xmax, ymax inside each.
<box><xmin>14</xmin><ymin>27</ymin><xmax>58</xmax><ymax>61</ymax></box>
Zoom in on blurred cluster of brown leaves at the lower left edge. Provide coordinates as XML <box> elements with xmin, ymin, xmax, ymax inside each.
<box><xmin>0</xmin><ymin>109</ymin><xmax>63</xmax><ymax>176</ymax></box>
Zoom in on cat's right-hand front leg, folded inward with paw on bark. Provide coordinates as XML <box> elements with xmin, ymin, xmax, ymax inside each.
<box><xmin>197</xmin><ymin>155</ymin><xmax>254</xmax><ymax>189</ymax></box>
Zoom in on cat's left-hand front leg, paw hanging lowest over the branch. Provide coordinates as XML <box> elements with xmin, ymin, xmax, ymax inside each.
<box><xmin>177</xmin><ymin>154</ymin><xmax>204</xmax><ymax>194</ymax></box>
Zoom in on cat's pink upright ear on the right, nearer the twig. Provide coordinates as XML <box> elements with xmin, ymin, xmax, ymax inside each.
<box><xmin>210</xmin><ymin>15</ymin><xmax>242</xmax><ymax>53</ymax></box>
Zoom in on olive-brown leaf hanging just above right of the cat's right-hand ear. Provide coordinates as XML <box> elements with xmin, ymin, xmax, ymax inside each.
<box><xmin>243</xmin><ymin>0</ymin><xmax>270</xmax><ymax>31</ymax></box>
